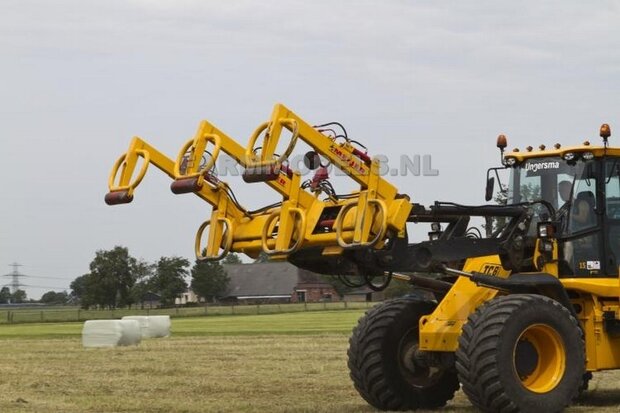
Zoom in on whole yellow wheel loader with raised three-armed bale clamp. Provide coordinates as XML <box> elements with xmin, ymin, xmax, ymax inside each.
<box><xmin>105</xmin><ymin>104</ymin><xmax>620</xmax><ymax>412</ymax></box>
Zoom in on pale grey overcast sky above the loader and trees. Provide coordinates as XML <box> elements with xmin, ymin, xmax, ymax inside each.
<box><xmin>0</xmin><ymin>0</ymin><xmax>620</xmax><ymax>298</ymax></box>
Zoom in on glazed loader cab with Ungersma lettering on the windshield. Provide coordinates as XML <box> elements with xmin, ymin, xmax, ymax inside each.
<box><xmin>508</xmin><ymin>147</ymin><xmax>620</xmax><ymax>277</ymax></box>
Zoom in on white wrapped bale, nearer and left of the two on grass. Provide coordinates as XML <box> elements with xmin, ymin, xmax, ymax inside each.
<box><xmin>82</xmin><ymin>320</ymin><xmax>142</xmax><ymax>347</ymax></box>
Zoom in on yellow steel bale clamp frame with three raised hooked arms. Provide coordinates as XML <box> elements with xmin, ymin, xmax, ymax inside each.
<box><xmin>108</xmin><ymin>104</ymin><xmax>411</xmax><ymax>259</ymax></box>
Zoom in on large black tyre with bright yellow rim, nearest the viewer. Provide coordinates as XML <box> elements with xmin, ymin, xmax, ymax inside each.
<box><xmin>456</xmin><ymin>294</ymin><xmax>585</xmax><ymax>413</ymax></box>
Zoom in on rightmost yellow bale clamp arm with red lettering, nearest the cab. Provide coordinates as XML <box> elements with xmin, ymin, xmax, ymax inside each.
<box><xmin>245</xmin><ymin>104</ymin><xmax>411</xmax><ymax>249</ymax></box>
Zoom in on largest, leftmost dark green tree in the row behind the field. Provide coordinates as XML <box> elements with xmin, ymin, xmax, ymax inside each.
<box><xmin>71</xmin><ymin>246</ymin><xmax>147</xmax><ymax>308</ymax></box>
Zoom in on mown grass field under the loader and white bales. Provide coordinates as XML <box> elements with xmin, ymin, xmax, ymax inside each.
<box><xmin>0</xmin><ymin>310</ymin><xmax>620</xmax><ymax>413</ymax></box>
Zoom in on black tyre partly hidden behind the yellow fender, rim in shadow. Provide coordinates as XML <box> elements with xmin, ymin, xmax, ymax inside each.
<box><xmin>348</xmin><ymin>297</ymin><xmax>459</xmax><ymax>410</ymax></box>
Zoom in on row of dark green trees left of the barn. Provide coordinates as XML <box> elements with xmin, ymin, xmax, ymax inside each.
<box><xmin>70</xmin><ymin>246</ymin><xmax>241</xmax><ymax>308</ymax></box>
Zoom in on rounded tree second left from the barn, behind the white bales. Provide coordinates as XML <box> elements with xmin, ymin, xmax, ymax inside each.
<box><xmin>150</xmin><ymin>257</ymin><xmax>189</xmax><ymax>306</ymax></box>
